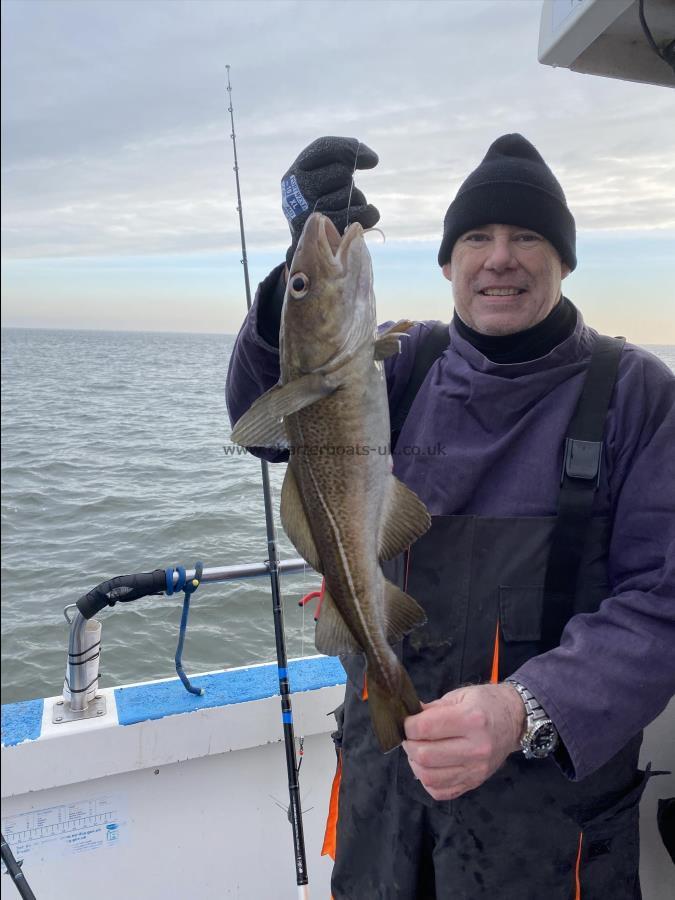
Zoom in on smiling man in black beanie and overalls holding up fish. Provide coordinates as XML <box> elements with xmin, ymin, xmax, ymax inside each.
<box><xmin>227</xmin><ymin>135</ymin><xmax>675</xmax><ymax>900</ymax></box>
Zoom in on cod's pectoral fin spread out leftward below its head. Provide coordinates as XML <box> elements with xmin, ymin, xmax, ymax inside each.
<box><xmin>232</xmin><ymin>372</ymin><xmax>339</xmax><ymax>447</ymax></box>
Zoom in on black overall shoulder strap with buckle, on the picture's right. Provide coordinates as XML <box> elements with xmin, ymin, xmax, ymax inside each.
<box><xmin>541</xmin><ymin>335</ymin><xmax>626</xmax><ymax>652</ymax></box>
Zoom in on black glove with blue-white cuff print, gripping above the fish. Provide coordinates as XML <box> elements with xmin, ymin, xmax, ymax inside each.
<box><xmin>281</xmin><ymin>137</ymin><xmax>380</xmax><ymax>267</ymax></box>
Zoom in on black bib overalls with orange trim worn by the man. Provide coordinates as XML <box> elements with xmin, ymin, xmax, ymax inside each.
<box><xmin>332</xmin><ymin>334</ymin><xmax>647</xmax><ymax>900</ymax></box>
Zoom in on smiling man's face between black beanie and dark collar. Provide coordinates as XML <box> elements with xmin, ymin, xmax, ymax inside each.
<box><xmin>443</xmin><ymin>225</ymin><xmax>570</xmax><ymax>335</ymax></box>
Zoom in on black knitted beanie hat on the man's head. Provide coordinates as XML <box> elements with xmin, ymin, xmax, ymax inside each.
<box><xmin>438</xmin><ymin>134</ymin><xmax>577</xmax><ymax>270</ymax></box>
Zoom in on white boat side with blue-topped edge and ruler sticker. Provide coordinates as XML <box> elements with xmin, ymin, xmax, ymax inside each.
<box><xmin>0</xmin><ymin>657</ymin><xmax>675</xmax><ymax>900</ymax></box>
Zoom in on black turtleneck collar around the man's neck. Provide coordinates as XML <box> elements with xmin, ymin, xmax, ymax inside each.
<box><xmin>453</xmin><ymin>297</ymin><xmax>577</xmax><ymax>365</ymax></box>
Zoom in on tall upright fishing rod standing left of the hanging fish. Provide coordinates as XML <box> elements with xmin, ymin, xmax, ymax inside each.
<box><xmin>225</xmin><ymin>65</ymin><xmax>309</xmax><ymax>900</ymax></box>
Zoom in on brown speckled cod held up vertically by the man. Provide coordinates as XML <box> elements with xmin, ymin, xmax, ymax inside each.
<box><xmin>232</xmin><ymin>213</ymin><xmax>431</xmax><ymax>752</ymax></box>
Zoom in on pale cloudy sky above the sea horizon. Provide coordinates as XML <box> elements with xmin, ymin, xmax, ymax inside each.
<box><xmin>2</xmin><ymin>0</ymin><xmax>675</xmax><ymax>344</ymax></box>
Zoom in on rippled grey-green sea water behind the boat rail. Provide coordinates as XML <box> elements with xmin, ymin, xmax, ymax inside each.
<box><xmin>2</xmin><ymin>329</ymin><xmax>675</xmax><ymax>703</ymax></box>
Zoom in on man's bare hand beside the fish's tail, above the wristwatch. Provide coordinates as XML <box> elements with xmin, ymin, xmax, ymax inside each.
<box><xmin>403</xmin><ymin>684</ymin><xmax>526</xmax><ymax>800</ymax></box>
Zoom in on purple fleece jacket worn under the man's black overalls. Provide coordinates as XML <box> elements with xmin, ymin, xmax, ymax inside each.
<box><xmin>226</xmin><ymin>270</ymin><xmax>675</xmax><ymax>780</ymax></box>
